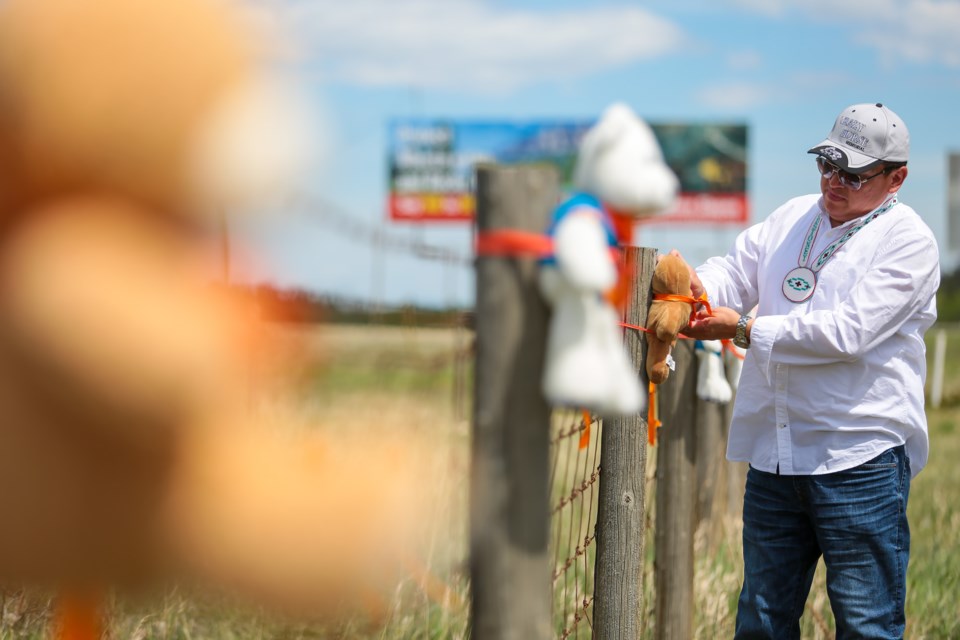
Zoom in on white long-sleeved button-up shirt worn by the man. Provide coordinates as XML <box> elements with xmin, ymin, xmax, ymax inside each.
<box><xmin>697</xmin><ymin>194</ymin><xmax>940</xmax><ymax>475</ymax></box>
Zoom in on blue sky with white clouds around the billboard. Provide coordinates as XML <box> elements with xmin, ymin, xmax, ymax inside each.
<box><xmin>235</xmin><ymin>0</ymin><xmax>960</xmax><ymax>305</ymax></box>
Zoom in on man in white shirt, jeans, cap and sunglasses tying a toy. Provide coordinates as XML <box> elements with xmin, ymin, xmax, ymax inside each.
<box><xmin>684</xmin><ymin>104</ymin><xmax>940</xmax><ymax>640</ymax></box>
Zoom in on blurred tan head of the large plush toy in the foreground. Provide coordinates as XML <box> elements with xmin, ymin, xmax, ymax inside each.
<box><xmin>0</xmin><ymin>0</ymin><xmax>312</xmax><ymax>214</ymax></box>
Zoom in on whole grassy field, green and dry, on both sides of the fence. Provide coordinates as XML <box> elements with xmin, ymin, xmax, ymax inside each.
<box><xmin>0</xmin><ymin>326</ymin><xmax>960</xmax><ymax>640</ymax></box>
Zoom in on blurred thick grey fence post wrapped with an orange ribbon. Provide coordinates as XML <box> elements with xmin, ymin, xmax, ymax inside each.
<box><xmin>470</xmin><ymin>165</ymin><xmax>560</xmax><ymax>640</ymax></box>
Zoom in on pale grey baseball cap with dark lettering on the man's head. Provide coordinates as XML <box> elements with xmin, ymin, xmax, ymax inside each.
<box><xmin>807</xmin><ymin>102</ymin><xmax>910</xmax><ymax>173</ymax></box>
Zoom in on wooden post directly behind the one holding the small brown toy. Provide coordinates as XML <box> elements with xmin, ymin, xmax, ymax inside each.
<box><xmin>654</xmin><ymin>340</ymin><xmax>697</xmax><ymax>640</ymax></box>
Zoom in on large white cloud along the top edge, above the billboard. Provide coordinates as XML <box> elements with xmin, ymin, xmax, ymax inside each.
<box><xmin>258</xmin><ymin>0</ymin><xmax>686</xmax><ymax>92</ymax></box>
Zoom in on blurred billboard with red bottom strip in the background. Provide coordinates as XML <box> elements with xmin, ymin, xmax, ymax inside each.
<box><xmin>387</xmin><ymin>118</ymin><xmax>749</xmax><ymax>225</ymax></box>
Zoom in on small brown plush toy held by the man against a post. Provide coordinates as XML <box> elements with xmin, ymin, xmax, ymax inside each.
<box><xmin>646</xmin><ymin>254</ymin><xmax>693</xmax><ymax>384</ymax></box>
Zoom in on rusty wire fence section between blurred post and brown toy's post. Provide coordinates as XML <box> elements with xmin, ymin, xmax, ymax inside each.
<box><xmin>550</xmin><ymin>410</ymin><xmax>602</xmax><ymax>639</ymax></box>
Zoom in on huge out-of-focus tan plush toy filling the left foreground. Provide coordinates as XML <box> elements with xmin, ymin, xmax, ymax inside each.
<box><xmin>0</xmin><ymin>0</ymin><xmax>428</xmax><ymax>632</ymax></box>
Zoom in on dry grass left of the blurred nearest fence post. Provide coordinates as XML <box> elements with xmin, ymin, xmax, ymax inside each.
<box><xmin>0</xmin><ymin>326</ymin><xmax>469</xmax><ymax>640</ymax></box>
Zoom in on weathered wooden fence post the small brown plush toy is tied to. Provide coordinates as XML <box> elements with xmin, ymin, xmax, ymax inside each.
<box><xmin>593</xmin><ymin>247</ymin><xmax>656</xmax><ymax>640</ymax></box>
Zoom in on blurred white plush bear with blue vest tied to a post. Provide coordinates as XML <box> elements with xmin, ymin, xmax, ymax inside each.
<box><xmin>540</xmin><ymin>103</ymin><xmax>678</xmax><ymax>415</ymax></box>
